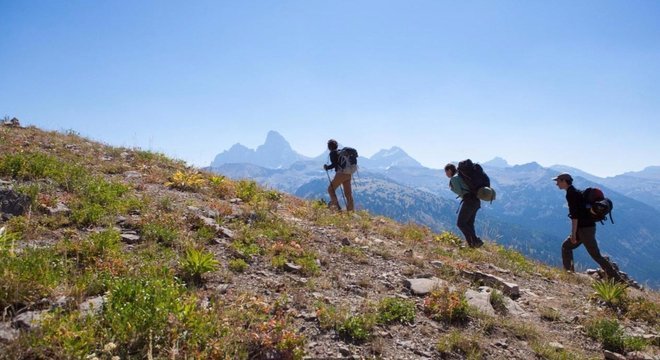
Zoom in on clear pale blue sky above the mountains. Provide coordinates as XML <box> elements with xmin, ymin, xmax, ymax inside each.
<box><xmin>0</xmin><ymin>0</ymin><xmax>660</xmax><ymax>176</ymax></box>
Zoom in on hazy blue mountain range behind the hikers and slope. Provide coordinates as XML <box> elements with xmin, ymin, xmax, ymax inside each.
<box><xmin>209</xmin><ymin>131</ymin><xmax>660</xmax><ymax>288</ymax></box>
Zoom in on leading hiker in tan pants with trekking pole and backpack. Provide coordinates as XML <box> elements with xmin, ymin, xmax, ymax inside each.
<box><xmin>323</xmin><ymin>139</ymin><xmax>358</xmax><ymax>211</ymax></box>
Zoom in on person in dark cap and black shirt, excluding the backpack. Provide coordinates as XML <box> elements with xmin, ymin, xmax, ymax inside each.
<box><xmin>552</xmin><ymin>173</ymin><xmax>623</xmax><ymax>282</ymax></box>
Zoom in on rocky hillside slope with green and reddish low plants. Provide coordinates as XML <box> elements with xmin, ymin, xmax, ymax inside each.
<box><xmin>0</xmin><ymin>125</ymin><xmax>660</xmax><ymax>360</ymax></box>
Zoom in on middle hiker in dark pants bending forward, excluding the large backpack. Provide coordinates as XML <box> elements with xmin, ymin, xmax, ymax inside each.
<box><xmin>445</xmin><ymin>163</ymin><xmax>484</xmax><ymax>248</ymax></box>
